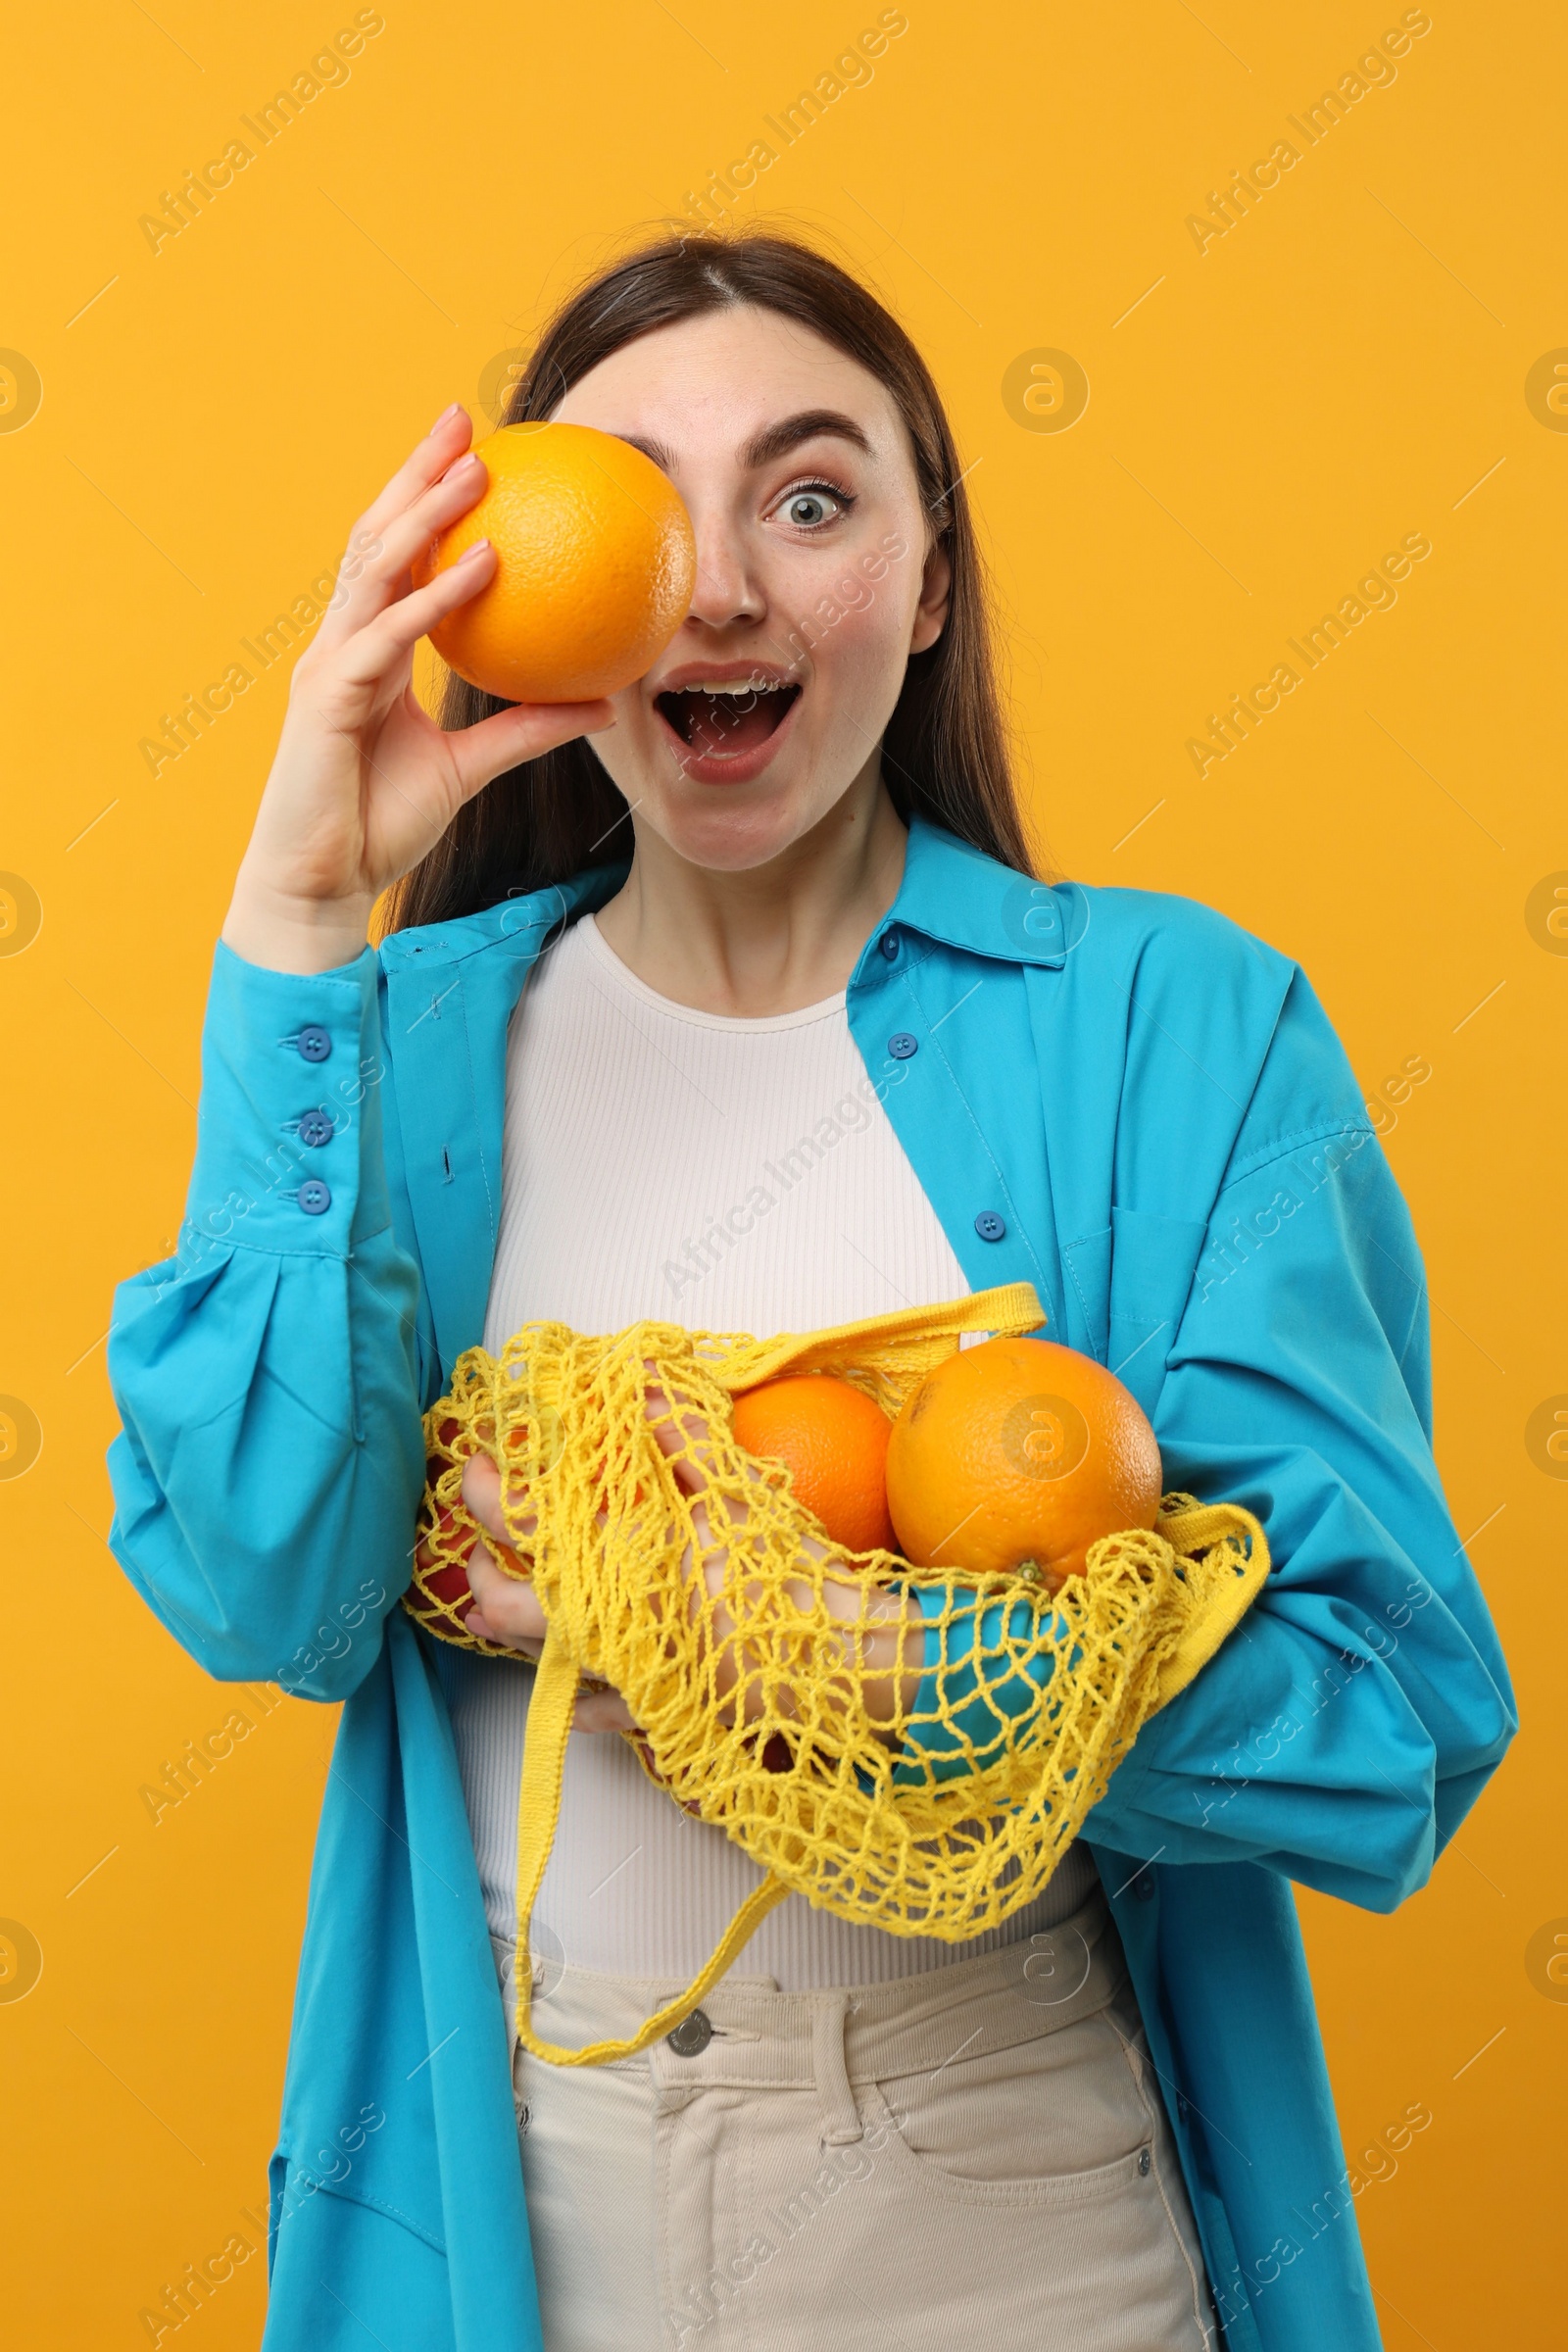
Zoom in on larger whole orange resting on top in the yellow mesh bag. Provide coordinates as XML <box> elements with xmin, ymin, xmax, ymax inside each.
<box><xmin>886</xmin><ymin>1339</ymin><xmax>1161</xmax><ymax>1592</ymax></box>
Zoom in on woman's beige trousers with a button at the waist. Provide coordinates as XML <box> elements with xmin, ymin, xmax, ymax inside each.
<box><xmin>513</xmin><ymin>1888</ymin><xmax>1218</xmax><ymax>2352</ymax></box>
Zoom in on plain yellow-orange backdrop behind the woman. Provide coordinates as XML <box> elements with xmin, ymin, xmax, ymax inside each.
<box><xmin>0</xmin><ymin>0</ymin><xmax>1568</xmax><ymax>2352</ymax></box>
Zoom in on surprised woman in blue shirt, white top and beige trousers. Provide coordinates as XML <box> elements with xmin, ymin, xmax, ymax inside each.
<box><xmin>111</xmin><ymin>235</ymin><xmax>1514</xmax><ymax>2352</ymax></box>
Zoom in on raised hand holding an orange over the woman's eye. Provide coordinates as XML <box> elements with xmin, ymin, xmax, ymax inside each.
<box><xmin>223</xmin><ymin>407</ymin><xmax>613</xmax><ymax>971</ymax></box>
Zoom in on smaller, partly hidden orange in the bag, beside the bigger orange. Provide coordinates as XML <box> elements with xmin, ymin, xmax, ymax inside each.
<box><xmin>733</xmin><ymin>1371</ymin><xmax>894</xmax><ymax>1552</ymax></box>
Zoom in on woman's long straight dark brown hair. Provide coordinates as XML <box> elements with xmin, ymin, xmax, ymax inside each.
<box><xmin>388</xmin><ymin>230</ymin><xmax>1034</xmax><ymax>929</ymax></box>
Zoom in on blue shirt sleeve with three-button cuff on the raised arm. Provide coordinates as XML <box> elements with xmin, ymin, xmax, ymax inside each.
<box><xmin>108</xmin><ymin>946</ymin><xmax>425</xmax><ymax>1700</ymax></box>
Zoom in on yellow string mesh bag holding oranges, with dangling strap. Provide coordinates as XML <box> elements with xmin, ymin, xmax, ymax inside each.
<box><xmin>405</xmin><ymin>1284</ymin><xmax>1269</xmax><ymax>2065</ymax></box>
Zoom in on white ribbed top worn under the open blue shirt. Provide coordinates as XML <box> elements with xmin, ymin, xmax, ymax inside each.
<box><xmin>437</xmin><ymin>915</ymin><xmax>1096</xmax><ymax>1992</ymax></box>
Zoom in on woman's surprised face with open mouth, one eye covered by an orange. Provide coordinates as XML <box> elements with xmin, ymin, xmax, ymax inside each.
<box><xmin>553</xmin><ymin>306</ymin><xmax>950</xmax><ymax>872</ymax></box>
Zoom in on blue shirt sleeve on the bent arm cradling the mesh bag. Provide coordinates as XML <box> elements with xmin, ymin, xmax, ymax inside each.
<box><xmin>903</xmin><ymin>971</ymin><xmax>1516</xmax><ymax>1910</ymax></box>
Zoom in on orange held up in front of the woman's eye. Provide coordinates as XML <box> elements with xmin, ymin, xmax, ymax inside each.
<box><xmin>412</xmin><ymin>423</ymin><xmax>696</xmax><ymax>704</ymax></box>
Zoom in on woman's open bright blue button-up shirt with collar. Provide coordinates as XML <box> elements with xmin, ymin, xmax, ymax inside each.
<box><xmin>108</xmin><ymin>821</ymin><xmax>1514</xmax><ymax>2352</ymax></box>
